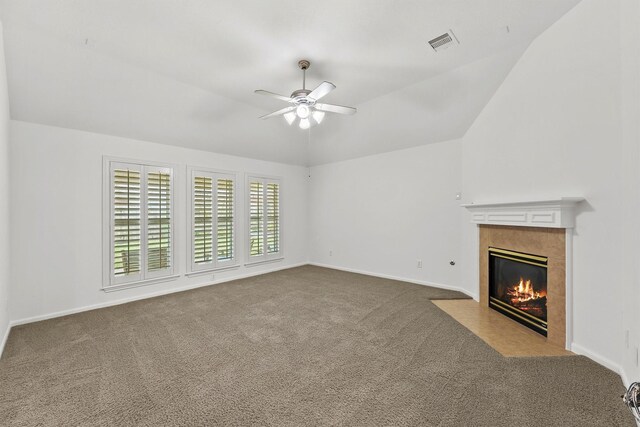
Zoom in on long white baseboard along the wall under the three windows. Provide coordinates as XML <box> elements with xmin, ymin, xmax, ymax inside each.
<box><xmin>8</xmin><ymin>262</ymin><xmax>307</xmax><ymax>328</ymax></box>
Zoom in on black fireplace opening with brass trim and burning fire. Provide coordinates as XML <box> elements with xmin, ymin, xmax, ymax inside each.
<box><xmin>489</xmin><ymin>247</ymin><xmax>547</xmax><ymax>337</ymax></box>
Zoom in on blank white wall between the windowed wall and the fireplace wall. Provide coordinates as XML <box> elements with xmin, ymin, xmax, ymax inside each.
<box><xmin>309</xmin><ymin>141</ymin><xmax>461</xmax><ymax>294</ymax></box>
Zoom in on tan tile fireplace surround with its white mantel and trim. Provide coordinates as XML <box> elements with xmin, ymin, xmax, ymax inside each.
<box><xmin>463</xmin><ymin>198</ymin><xmax>584</xmax><ymax>349</ymax></box>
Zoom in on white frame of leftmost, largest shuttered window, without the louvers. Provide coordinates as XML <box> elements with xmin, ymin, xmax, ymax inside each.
<box><xmin>102</xmin><ymin>156</ymin><xmax>180</xmax><ymax>292</ymax></box>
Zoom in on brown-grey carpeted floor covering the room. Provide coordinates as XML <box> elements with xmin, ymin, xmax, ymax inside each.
<box><xmin>0</xmin><ymin>266</ymin><xmax>634</xmax><ymax>427</ymax></box>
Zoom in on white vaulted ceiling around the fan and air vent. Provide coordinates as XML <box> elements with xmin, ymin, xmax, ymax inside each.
<box><xmin>0</xmin><ymin>0</ymin><xmax>579</xmax><ymax>165</ymax></box>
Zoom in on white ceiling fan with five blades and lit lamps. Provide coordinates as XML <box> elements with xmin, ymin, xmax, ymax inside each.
<box><xmin>255</xmin><ymin>59</ymin><xmax>357</xmax><ymax>129</ymax></box>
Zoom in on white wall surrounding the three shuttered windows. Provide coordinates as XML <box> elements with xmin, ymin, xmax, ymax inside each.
<box><xmin>11</xmin><ymin>121</ymin><xmax>308</xmax><ymax>322</ymax></box>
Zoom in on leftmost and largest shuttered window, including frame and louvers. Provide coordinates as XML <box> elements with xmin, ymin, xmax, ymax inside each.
<box><xmin>103</xmin><ymin>159</ymin><xmax>175</xmax><ymax>289</ymax></box>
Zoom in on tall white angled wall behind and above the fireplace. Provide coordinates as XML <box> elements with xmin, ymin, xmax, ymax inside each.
<box><xmin>462</xmin><ymin>0</ymin><xmax>640</xmax><ymax>369</ymax></box>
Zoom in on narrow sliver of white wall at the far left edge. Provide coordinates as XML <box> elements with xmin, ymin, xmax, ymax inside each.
<box><xmin>0</xmin><ymin>23</ymin><xmax>11</xmax><ymax>356</ymax></box>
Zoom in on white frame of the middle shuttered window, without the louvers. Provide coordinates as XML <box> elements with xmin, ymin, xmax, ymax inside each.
<box><xmin>187</xmin><ymin>166</ymin><xmax>239</xmax><ymax>275</ymax></box>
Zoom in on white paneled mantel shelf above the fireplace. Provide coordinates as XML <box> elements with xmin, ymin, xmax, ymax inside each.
<box><xmin>462</xmin><ymin>197</ymin><xmax>584</xmax><ymax>228</ymax></box>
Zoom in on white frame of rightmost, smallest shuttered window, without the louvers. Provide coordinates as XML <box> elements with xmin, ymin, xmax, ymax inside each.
<box><xmin>244</xmin><ymin>174</ymin><xmax>284</xmax><ymax>266</ymax></box>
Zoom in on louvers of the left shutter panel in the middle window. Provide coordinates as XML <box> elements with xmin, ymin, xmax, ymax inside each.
<box><xmin>193</xmin><ymin>176</ymin><xmax>213</xmax><ymax>264</ymax></box>
